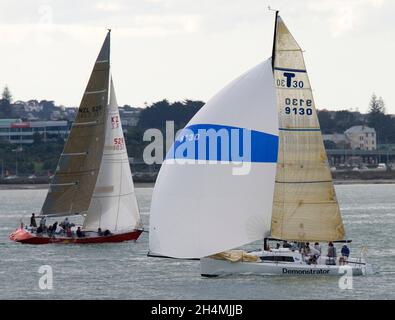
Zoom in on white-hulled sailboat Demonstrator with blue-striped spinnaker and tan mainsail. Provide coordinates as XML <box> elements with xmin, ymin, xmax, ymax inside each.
<box><xmin>149</xmin><ymin>12</ymin><xmax>367</xmax><ymax>276</ymax></box>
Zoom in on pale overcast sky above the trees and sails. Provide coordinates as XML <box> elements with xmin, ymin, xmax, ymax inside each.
<box><xmin>0</xmin><ymin>0</ymin><xmax>395</xmax><ymax>114</ymax></box>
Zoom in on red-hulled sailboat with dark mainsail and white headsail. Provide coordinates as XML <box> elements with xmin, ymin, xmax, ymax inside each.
<box><xmin>10</xmin><ymin>30</ymin><xmax>143</xmax><ymax>244</ymax></box>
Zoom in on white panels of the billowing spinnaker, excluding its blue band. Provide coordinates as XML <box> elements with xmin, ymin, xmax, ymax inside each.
<box><xmin>149</xmin><ymin>59</ymin><xmax>278</xmax><ymax>258</ymax></box>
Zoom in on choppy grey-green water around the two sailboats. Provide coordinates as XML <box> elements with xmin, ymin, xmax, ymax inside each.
<box><xmin>0</xmin><ymin>184</ymin><xmax>395</xmax><ymax>299</ymax></box>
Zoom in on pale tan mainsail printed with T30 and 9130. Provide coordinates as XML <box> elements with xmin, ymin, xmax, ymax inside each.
<box><xmin>271</xmin><ymin>17</ymin><xmax>344</xmax><ymax>241</ymax></box>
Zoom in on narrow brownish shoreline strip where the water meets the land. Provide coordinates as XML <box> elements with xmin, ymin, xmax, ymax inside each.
<box><xmin>0</xmin><ymin>179</ymin><xmax>395</xmax><ymax>190</ymax></box>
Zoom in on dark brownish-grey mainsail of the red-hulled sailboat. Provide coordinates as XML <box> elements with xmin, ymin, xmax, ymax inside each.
<box><xmin>41</xmin><ymin>32</ymin><xmax>110</xmax><ymax>215</ymax></box>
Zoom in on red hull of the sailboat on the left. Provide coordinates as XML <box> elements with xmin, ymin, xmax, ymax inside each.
<box><xmin>10</xmin><ymin>228</ymin><xmax>143</xmax><ymax>244</ymax></box>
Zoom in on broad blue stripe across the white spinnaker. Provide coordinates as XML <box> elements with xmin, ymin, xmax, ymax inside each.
<box><xmin>166</xmin><ymin>124</ymin><xmax>278</xmax><ymax>163</ymax></box>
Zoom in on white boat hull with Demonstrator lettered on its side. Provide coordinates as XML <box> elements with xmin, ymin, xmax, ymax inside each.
<box><xmin>200</xmin><ymin>258</ymin><xmax>365</xmax><ymax>277</ymax></box>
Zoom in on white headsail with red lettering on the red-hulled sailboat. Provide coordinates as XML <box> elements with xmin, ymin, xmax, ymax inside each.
<box><xmin>84</xmin><ymin>81</ymin><xmax>140</xmax><ymax>231</ymax></box>
